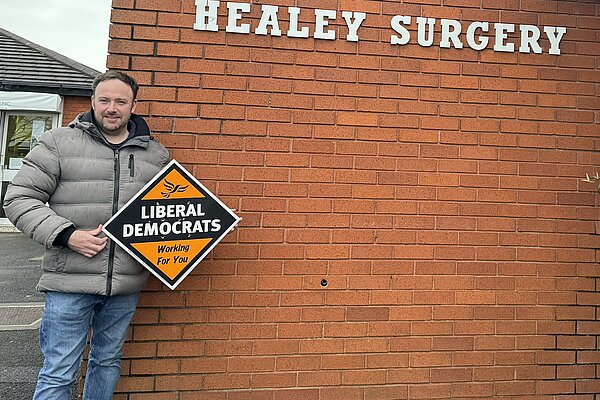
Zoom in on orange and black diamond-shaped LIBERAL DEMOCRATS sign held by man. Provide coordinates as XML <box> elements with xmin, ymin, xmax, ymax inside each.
<box><xmin>103</xmin><ymin>160</ymin><xmax>240</xmax><ymax>289</ymax></box>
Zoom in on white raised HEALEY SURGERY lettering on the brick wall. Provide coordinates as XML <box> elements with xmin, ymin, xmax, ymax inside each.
<box><xmin>194</xmin><ymin>0</ymin><xmax>567</xmax><ymax>55</ymax></box>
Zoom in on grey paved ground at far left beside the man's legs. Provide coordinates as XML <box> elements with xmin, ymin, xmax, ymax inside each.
<box><xmin>0</xmin><ymin>233</ymin><xmax>44</xmax><ymax>400</ymax></box>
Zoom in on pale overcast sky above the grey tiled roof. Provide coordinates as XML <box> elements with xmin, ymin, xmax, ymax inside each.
<box><xmin>0</xmin><ymin>0</ymin><xmax>112</xmax><ymax>72</ymax></box>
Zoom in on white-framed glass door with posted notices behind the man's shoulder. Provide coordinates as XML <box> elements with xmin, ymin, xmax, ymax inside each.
<box><xmin>0</xmin><ymin>111</ymin><xmax>58</xmax><ymax>222</ymax></box>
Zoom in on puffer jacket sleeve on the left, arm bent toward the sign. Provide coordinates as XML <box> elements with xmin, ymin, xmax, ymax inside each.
<box><xmin>4</xmin><ymin>131</ymin><xmax>73</xmax><ymax>248</ymax></box>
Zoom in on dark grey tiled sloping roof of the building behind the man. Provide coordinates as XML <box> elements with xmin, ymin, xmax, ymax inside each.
<box><xmin>0</xmin><ymin>28</ymin><xmax>100</xmax><ymax>96</ymax></box>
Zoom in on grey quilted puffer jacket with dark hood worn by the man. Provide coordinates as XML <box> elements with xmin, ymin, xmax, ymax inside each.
<box><xmin>4</xmin><ymin>112</ymin><xmax>169</xmax><ymax>295</ymax></box>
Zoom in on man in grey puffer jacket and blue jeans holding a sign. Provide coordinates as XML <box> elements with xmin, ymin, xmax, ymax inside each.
<box><xmin>4</xmin><ymin>71</ymin><xmax>169</xmax><ymax>400</ymax></box>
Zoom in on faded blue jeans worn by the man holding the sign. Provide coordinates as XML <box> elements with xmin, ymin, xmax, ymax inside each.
<box><xmin>33</xmin><ymin>292</ymin><xmax>138</xmax><ymax>400</ymax></box>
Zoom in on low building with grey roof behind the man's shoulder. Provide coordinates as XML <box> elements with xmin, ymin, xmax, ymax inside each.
<box><xmin>0</xmin><ymin>28</ymin><xmax>99</xmax><ymax>226</ymax></box>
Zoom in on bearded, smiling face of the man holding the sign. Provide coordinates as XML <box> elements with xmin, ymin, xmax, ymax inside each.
<box><xmin>92</xmin><ymin>79</ymin><xmax>137</xmax><ymax>136</ymax></box>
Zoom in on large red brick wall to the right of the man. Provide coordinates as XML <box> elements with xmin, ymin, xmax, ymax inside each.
<box><xmin>108</xmin><ymin>0</ymin><xmax>600</xmax><ymax>400</ymax></box>
